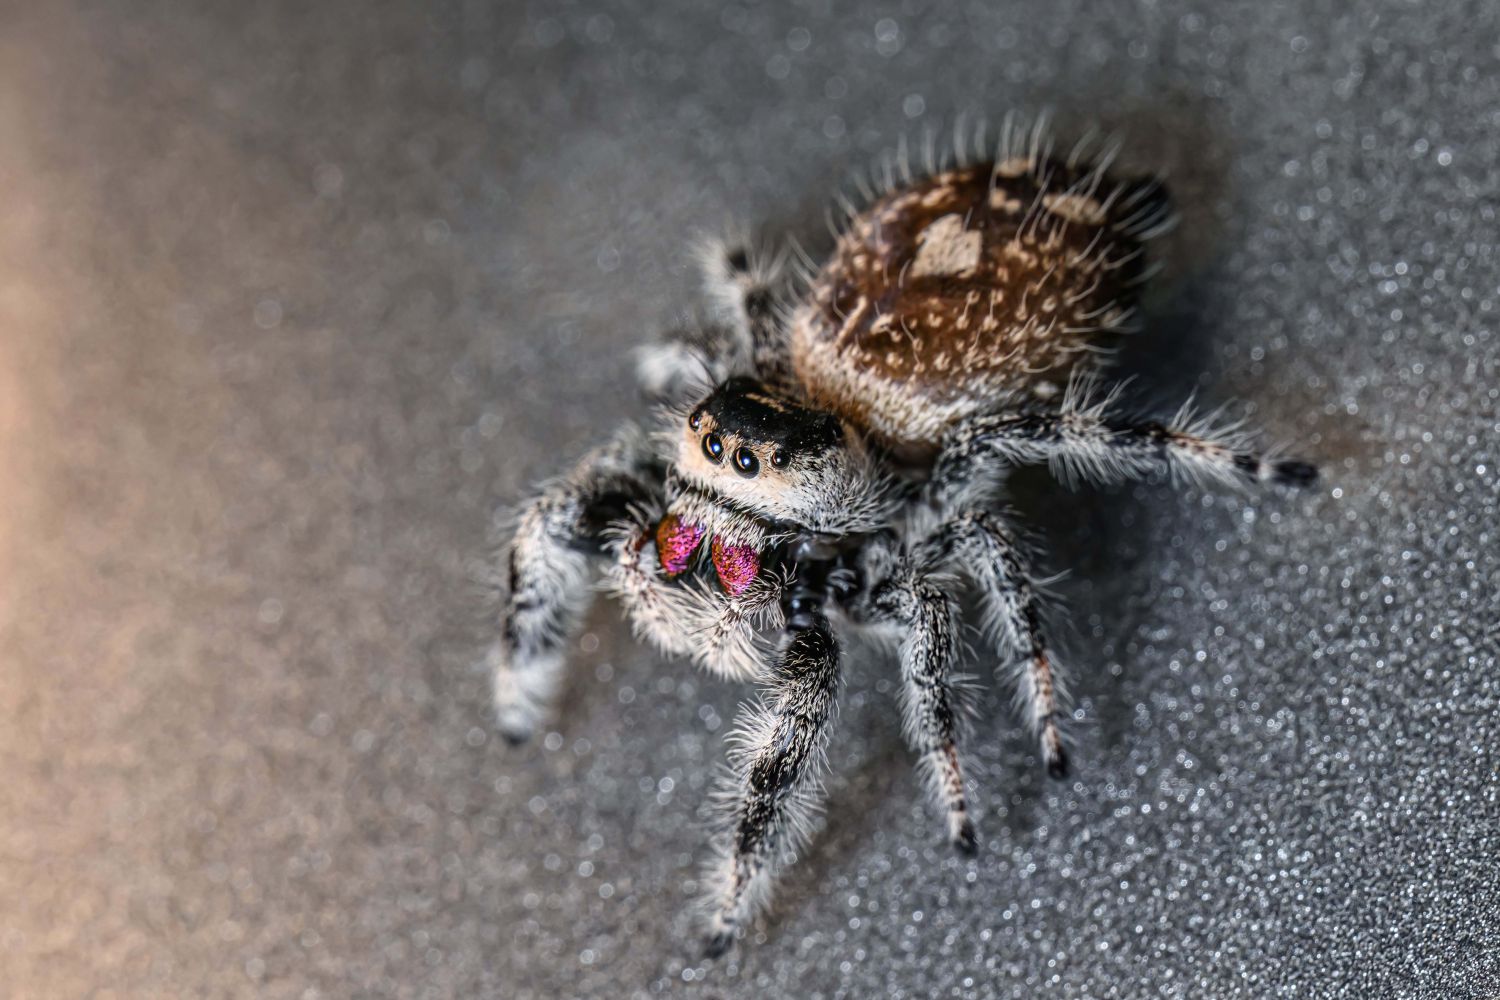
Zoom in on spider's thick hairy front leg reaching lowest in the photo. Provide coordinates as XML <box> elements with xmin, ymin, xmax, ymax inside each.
<box><xmin>707</xmin><ymin>610</ymin><xmax>840</xmax><ymax>957</ymax></box>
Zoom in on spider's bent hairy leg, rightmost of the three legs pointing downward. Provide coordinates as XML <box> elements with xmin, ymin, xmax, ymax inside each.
<box><xmin>921</xmin><ymin>510</ymin><xmax>1068</xmax><ymax>778</ymax></box>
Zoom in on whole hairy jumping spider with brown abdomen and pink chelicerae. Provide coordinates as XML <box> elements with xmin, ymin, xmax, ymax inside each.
<box><xmin>486</xmin><ymin>127</ymin><xmax>1317</xmax><ymax>954</ymax></box>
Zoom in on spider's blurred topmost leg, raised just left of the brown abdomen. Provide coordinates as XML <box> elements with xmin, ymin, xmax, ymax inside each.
<box><xmin>698</xmin><ymin>234</ymin><xmax>789</xmax><ymax>378</ymax></box>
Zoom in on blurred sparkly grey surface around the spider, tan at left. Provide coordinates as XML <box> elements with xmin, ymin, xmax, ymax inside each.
<box><xmin>0</xmin><ymin>0</ymin><xmax>1500</xmax><ymax>999</ymax></box>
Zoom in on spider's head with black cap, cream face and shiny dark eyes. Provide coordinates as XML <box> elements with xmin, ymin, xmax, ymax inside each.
<box><xmin>677</xmin><ymin>378</ymin><xmax>861</xmax><ymax>528</ymax></box>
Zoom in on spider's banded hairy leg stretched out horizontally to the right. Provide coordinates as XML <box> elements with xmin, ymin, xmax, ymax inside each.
<box><xmin>933</xmin><ymin>385</ymin><xmax>1317</xmax><ymax>505</ymax></box>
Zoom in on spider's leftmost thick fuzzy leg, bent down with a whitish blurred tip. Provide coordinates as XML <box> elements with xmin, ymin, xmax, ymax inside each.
<box><xmin>485</xmin><ymin>427</ymin><xmax>659</xmax><ymax>744</ymax></box>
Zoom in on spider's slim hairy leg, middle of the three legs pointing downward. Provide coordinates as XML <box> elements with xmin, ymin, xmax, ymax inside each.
<box><xmin>864</xmin><ymin>558</ymin><xmax>977</xmax><ymax>853</ymax></box>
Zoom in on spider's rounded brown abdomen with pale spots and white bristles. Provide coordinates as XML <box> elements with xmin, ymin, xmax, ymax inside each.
<box><xmin>792</xmin><ymin>159</ymin><xmax>1167</xmax><ymax>451</ymax></box>
